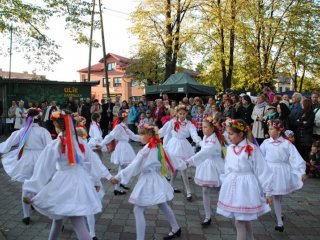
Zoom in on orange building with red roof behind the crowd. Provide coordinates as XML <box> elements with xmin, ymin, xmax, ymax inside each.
<box><xmin>78</xmin><ymin>53</ymin><xmax>145</xmax><ymax>100</ymax></box>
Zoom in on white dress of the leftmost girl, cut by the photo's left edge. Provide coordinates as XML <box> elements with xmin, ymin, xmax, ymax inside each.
<box><xmin>0</xmin><ymin>123</ymin><xmax>52</xmax><ymax>182</ymax></box>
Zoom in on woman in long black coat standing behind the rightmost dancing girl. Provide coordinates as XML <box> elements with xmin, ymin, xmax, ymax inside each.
<box><xmin>293</xmin><ymin>99</ymin><xmax>314</xmax><ymax>162</ymax></box>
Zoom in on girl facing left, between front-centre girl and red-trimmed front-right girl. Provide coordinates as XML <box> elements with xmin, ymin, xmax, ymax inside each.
<box><xmin>186</xmin><ymin>116</ymin><xmax>224</xmax><ymax>226</ymax></box>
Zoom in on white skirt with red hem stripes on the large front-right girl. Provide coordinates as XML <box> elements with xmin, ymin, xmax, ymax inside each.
<box><xmin>217</xmin><ymin>173</ymin><xmax>271</xmax><ymax>221</ymax></box>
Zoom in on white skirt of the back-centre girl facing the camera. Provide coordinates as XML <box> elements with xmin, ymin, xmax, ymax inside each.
<box><xmin>165</xmin><ymin>137</ymin><xmax>195</xmax><ymax>170</ymax></box>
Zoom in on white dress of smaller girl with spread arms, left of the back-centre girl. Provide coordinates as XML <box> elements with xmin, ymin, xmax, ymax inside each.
<box><xmin>100</xmin><ymin>123</ymin><xmax>140</xmax><ymax>166</ymax></box>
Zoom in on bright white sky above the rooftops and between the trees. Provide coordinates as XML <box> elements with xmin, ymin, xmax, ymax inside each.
<box><xmin>0</xmin><ymin>0</ymin><xmax>139</xmax><ymax>81</ymax></box>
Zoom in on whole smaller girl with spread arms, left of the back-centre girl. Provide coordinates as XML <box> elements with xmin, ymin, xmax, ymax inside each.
<box><xmin>100</xmin><ymin>110</ymin><xmax>140</xmax><ymax>195</ymax></box>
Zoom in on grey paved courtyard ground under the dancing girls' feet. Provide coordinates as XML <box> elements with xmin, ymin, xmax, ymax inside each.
<box><xmin>0</xmin><ymin>143</ymin><xmax>320</xmax><ymax>240</ymax></box>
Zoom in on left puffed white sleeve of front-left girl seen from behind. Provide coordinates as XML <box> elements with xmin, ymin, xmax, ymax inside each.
<box><xmin>23</xmin><ymin>142</ymin><xmax>60</xmax><ymax>194</ymax></box>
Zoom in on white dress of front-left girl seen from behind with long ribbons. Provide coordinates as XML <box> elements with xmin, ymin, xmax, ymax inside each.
<box><xmin>23</xmin><ymin>136</ymin><xmax>104</xmax><ymax>219</ymax></box>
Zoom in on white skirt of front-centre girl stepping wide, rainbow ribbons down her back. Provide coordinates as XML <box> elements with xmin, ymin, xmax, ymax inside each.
<box><xmin>129</xmin><ymin>171</ymin><xmax>173</xmax><ymax>207</ymax></box>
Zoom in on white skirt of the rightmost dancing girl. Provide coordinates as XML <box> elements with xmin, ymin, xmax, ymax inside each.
<box><xmin>267</xmin><ymin>162</ymin><xmax>303</xmax><ymax>195</ymax></box>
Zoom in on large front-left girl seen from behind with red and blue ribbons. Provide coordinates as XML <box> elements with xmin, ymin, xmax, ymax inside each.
<box><xmin>23</xmin><ymin>111</ymin><xmax>111</xmax><ymax>240</ymax></box>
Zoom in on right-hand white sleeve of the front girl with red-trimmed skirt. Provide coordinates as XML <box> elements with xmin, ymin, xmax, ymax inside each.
<box><xmin>251</xmin><ymin>144</ymin><xmax>273</xmax><ymax>196</ymax></box>
